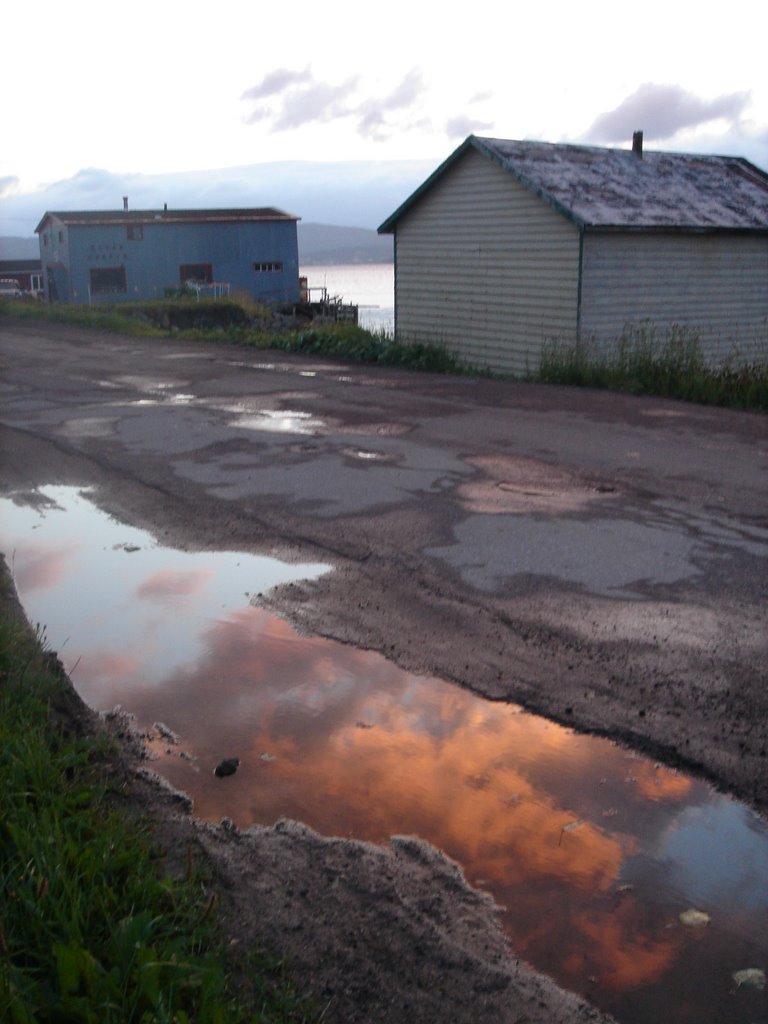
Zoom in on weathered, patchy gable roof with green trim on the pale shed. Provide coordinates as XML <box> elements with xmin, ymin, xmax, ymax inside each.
<box><xmin>379</xmin><ymin>135</ymin><xmax>768</xmax><ymax>233</ymax></box>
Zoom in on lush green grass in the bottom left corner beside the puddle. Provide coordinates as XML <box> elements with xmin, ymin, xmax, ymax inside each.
<box><xmin>0</xmin><ymin>589</ymin><xmax>311</xmax><ymax>1024</ymax></box>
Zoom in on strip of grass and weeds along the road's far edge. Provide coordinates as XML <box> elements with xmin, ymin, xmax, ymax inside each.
<box><xmin>0</xmin><ymin>295</ymin><xmax>768</xmax><ymax>411</ymax></box>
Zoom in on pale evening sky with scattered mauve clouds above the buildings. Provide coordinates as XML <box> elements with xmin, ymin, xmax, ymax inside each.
<box><xmin>0</xmin><ymin>0</ymin><xmax>768</xmax><ymax>234</ymax></box>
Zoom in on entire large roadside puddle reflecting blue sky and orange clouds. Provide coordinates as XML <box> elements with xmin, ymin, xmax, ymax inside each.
<box><xmin>0</xmin><ymin>487</ymin><xmax>768</xmax><ymax>1024</ymax></box>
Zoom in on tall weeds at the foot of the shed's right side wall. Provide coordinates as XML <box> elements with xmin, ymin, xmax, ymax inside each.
<box><xmin>534</xmin><ymin>326</ymin><xmax>768</xmax><ymax>411</ymax></box>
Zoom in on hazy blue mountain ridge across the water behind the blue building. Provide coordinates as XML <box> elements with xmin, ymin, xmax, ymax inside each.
<box><xmin>0</xmin><ymin>221</ymin><xmax>394</xmax><ymax>265</ymax></box>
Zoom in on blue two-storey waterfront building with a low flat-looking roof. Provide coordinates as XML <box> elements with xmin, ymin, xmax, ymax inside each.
<box><xmin>35</xmin><ymin>200</ymin><xmax>299</xmax><ymax>305</ymax></box>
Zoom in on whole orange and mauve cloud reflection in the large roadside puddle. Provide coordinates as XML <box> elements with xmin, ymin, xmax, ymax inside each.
<box><xmin>111</xmin><ymin>608</ymin><xmax>708</xmax><ymax>1003</ymax></box>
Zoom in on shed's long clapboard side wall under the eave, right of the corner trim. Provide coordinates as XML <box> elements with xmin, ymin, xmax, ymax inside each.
<box><xmin>580</xmin><ymin>231</ymin><xmax>768</xmax><ymax>362</ymax></box>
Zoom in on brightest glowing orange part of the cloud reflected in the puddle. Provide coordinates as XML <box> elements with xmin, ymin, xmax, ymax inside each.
<box><xmin>244</xmin><ymin>712</ymin><xmax>624</xmax><ymax>892</ymax></box>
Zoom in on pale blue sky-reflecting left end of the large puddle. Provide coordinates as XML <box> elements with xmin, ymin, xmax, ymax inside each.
<box><xmin>0</xmin><ymin>487</ymin><xmax>329</xmax><ymax>696</ymax></box>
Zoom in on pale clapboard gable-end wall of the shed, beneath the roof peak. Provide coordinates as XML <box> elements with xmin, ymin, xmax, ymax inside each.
<box><xmin>395</xmin><ymin>151</ymin><xmax>579</xmax><ymax>374</ymax></box>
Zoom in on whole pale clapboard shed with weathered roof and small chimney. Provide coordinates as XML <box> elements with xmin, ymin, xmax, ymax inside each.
<box><xmin>379</xmin><ymin>132</ymin><xmax>768</xmax><ymax>374</ymax></box>
